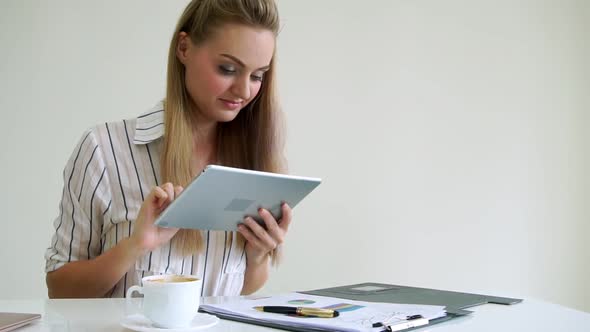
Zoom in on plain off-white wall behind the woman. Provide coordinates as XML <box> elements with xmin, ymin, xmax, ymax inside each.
<box><xmin>0</xmin><ymin>0</ymin><xmax>590</xmax><ymax>311</ymax></box>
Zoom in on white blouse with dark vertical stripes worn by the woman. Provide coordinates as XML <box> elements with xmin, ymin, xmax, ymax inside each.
<box><xmin>45</xmin><ymin>103</ymin><xmax>246</xmax><ymax>297</ymax></box>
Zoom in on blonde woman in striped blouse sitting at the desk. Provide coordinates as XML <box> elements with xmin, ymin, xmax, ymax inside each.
<box><xmin>45</xmin><ymin>0</ymin><xmax>291</xmax><ymax>298</ymax></box>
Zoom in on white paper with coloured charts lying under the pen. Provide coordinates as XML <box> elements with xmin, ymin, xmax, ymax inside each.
<box><xmin>201</xmin><ymin>293</ymin><xmax>446</xmax><ymax>331</ymax></box>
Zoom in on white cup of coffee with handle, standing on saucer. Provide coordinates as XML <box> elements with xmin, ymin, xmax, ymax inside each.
<box><xmin>127</xmin><ymin>275</ymin><xmax>203</xmax><ymax>328</ymax></box>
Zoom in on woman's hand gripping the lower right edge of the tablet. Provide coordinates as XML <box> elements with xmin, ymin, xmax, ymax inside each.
<box><xmin>238</xmin><ymin>203</ymin><xmax>292</xmax><ymax>264</ymax></box>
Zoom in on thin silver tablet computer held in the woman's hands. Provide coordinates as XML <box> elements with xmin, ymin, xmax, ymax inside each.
<box><xmin>155</xmin><ymin>165</ymin><xmax>321</xmax><ymax>231</ymax></box>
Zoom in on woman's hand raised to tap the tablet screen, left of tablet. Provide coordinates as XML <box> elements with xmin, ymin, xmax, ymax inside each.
<box><xmin>130</xmin><ymin>182</ymin><xmax>184</xmax><ymax>252</ymax></box>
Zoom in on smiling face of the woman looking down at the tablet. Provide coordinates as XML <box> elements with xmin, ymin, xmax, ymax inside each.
<box><xmin>176</xmin><ymin>24</ymin><xmax>275</xmax><ymax>122</ymax></box>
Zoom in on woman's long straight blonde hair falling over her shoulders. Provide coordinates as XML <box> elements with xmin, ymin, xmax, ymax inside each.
<box><xmin>161</xmin><ymin>0</ymin><xmax>286</xmax><ymax>264</ymax></box>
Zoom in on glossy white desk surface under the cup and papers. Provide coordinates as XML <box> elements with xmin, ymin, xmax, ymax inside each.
<box><xmin>0</xmin><ymin>298</ymin><xmax>590</xmax><ymax>332</ymax></box>
